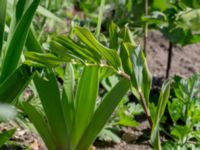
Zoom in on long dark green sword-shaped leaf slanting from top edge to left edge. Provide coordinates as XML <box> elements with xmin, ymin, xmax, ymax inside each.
<box><xmin>0</xmin><ymin>0</ymin><xmax>40</xmax><ymax>82</ymax></box>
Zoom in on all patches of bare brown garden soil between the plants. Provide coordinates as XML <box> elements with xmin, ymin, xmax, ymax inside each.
<box><xmin>0</xmin><ymin>31</ymin><xmax>200</xmax><ymax>150</ymax></box>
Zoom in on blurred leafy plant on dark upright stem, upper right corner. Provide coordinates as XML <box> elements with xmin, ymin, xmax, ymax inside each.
<box><xmin>146</xmin><ymin>0</ymin><xmax>200</xmax><ymax>78</ymax></box>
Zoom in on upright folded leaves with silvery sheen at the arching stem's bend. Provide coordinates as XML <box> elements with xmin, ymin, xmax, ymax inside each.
<box><xmin>120</xmin><ymin>43</ymin><xmax>152</xmax><ymax>107</ymax></box>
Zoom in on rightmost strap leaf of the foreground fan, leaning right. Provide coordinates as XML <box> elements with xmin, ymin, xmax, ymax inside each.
<box><xmin>76</xmin><ymin>79</ymin><xmax>130</xmax><ymax>150</ymax></box>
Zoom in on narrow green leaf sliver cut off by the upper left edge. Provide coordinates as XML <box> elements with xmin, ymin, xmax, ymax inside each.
<box><xmin>0</xmin><ymin>0</ymin><xmax>7</xmax><ymax>53</ymax></box>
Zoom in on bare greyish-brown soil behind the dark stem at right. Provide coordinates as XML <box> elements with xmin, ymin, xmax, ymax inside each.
<box><xmin>147</xmin><ymin>31</ymin><xmax>200</xmax><ymax>77</ymax></box>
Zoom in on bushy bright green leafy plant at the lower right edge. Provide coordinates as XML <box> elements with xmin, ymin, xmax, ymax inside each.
<box><xmin>163</xmin><ymin>74</ymin><xmax>200</xmax><ymax>147</ymax></box>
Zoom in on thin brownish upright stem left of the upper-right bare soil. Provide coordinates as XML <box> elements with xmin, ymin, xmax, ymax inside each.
<box><xmin>144</xmin><ymin>0</ymin><xmax>148</xmax><ymax>55</ymax></box>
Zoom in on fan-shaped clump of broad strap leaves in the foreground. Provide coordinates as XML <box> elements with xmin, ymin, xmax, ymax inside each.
<box><xmin>23</xmin><ymin>66</ymin><xmax>129</xmax><ymax>150</ymax></box>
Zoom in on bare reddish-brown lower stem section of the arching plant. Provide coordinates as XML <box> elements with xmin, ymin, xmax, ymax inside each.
<box><xmin>139</xmin><ymin>92</ymin><xmax>153</xmax><ymax>128</ymax></box>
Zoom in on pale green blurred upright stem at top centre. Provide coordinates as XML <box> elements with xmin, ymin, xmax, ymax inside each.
<box><xmin>96</xmin><ymin>0</ymin><xmax>105</xmax><ymax>38</ymax></box>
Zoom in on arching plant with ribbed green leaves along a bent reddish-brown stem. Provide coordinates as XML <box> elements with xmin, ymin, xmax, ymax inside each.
<box><xmin>38</xmin><ymin>25</ymin><xmax>171</xmax><ymax>149</ymax></box>
